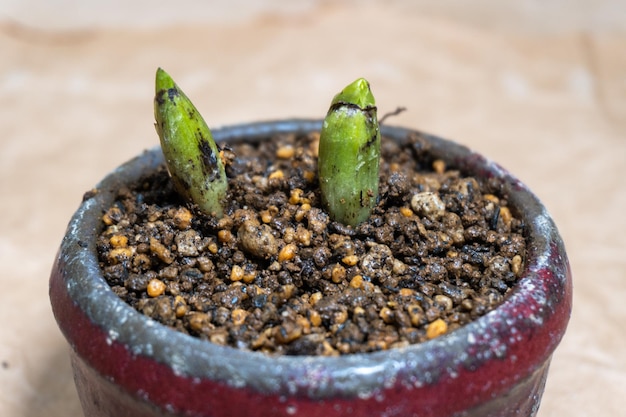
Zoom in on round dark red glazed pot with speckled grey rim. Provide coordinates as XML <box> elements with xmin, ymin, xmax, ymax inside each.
<box><xmin>50</xmin><ymin>120</ymin><xmax>572</xmax><ymax>417</ymax></box>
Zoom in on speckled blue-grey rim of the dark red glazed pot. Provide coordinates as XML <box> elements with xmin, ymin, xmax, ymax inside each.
<box><xmin>53</xmin><ymin>119</ymin><xmax>571</xmax><ymax>398</ymax></box>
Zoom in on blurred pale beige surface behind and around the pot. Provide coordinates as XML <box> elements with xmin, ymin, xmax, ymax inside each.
<box><xmin>0</xmin><ymin>0</ymin><xmax>626</xmax><ymax>417</ymax></box>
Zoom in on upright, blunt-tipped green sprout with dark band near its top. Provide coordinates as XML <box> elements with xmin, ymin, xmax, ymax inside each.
<box><xmin>318</xmin><ymin>78</ymin><xmax>380</xmax><ymax>226</ymax></box>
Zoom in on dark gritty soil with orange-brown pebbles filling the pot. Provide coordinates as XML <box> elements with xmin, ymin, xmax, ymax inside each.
<box><xmin>98</xmin><ymin>134</ymin><xmax>525</xmax><ymax>355</ymax></box>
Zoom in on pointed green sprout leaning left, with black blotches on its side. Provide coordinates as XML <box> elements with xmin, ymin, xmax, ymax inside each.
<box><xmin>154</xmin><ymin>68</ymin><xmax>228</xmax><ymax>218</ymax></box>
